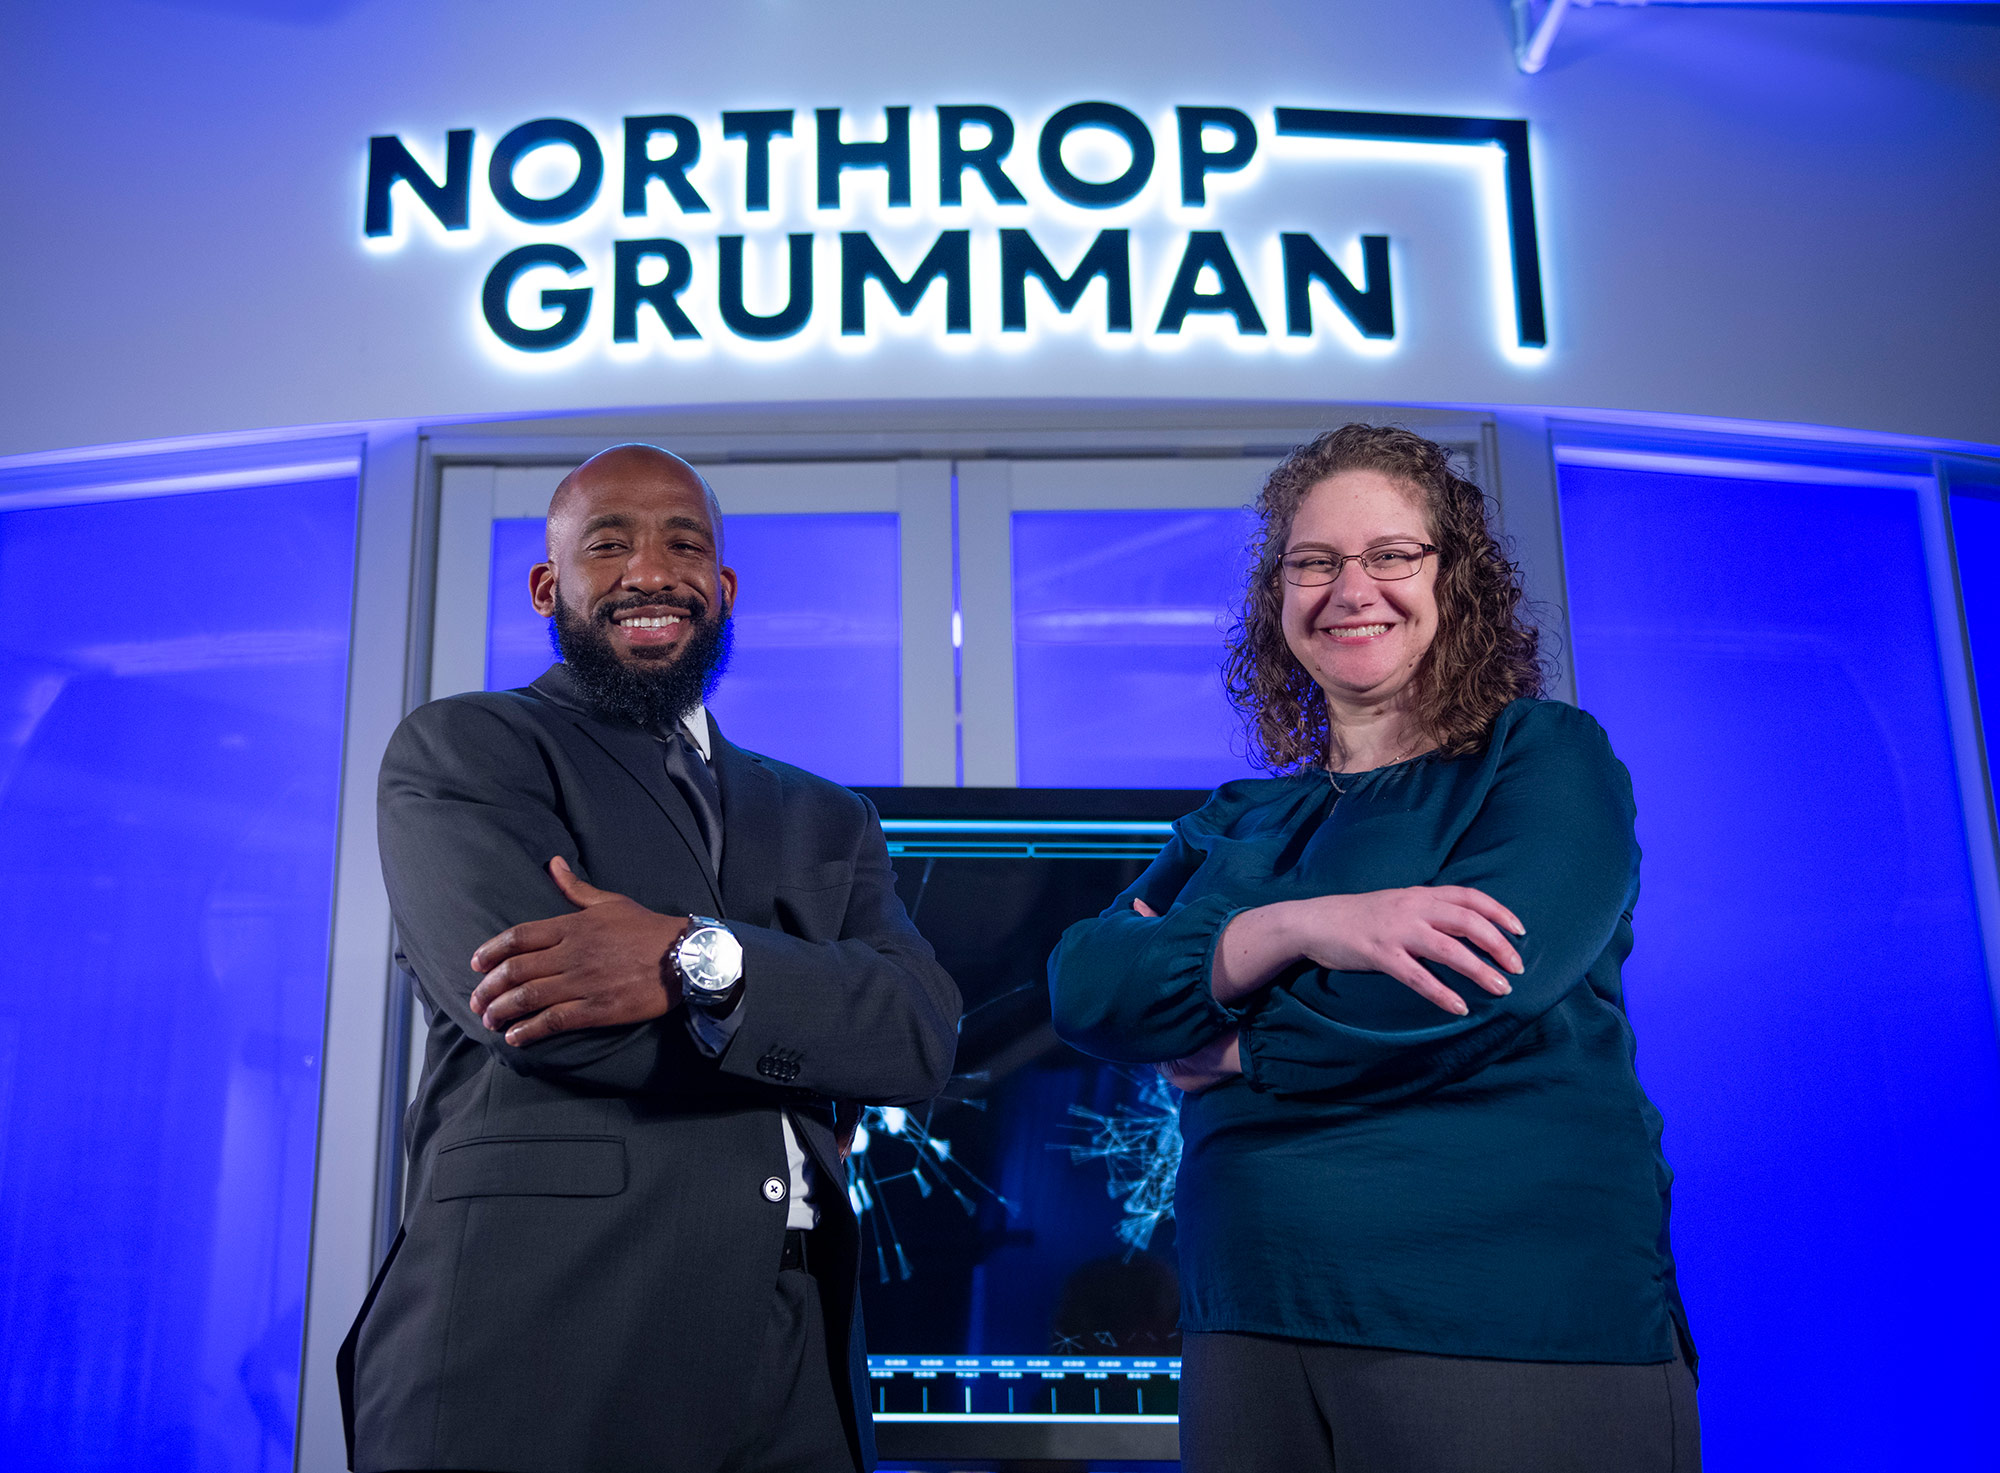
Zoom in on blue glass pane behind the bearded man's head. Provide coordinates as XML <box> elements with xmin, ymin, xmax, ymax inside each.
<box><xmin>486</xmin><ymin>512</ymin><xmax>902</xmax><ymax>787</ymax></box>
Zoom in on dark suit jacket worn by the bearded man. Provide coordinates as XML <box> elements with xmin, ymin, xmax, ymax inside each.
<box><xmin>342</xmin><ymin>664</ymin><xmax>958</xmax><ymax>1473</ymax></box>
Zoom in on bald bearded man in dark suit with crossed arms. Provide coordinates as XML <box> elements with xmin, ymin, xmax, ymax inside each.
<box><xmin>342</xmin><ymin>446</ymin><xmax>958</xmax><ymax>1473</ymax></box>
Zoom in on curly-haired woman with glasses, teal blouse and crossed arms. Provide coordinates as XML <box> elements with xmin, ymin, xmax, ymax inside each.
<box><xmin>1050</xmin><ymin>424</ymin><xmax>1700</xmax><ymax>1473</ymax></box>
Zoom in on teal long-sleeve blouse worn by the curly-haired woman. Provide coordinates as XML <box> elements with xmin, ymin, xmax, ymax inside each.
<box><xmin>1050</xmin><ymin>700</ymin><xmax>1686</xmax><ymax>1365</ymax></box>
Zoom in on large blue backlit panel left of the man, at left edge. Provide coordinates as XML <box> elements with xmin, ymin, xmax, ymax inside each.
<box><xmin>0</xmin><ymin>478</ymin><xmax>358</xmax><ymax>1473</ymax></box>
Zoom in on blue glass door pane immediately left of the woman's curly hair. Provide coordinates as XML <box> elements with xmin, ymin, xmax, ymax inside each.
<box><xmin>1014</xmin><ymin>510</ymin><xmax>1254</xmax><ymax>789</ymax></box>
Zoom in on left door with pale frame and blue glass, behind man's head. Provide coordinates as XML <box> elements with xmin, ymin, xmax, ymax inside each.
<box><xmin>430</xmin><ymin>460</ymin><xmax>954</xmax><ymax>787</ymax></box>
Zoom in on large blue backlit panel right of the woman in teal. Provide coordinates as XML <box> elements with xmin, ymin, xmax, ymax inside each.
<box><xmin>1560</xmin><ymin>466</ymin><xmax>2000</xmax><ymax>1473</ymax></box>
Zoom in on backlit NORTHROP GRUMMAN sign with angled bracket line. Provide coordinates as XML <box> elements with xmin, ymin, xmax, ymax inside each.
<box><xmin>362</xmin><ymin>102</ymin><xmax>1548</xmax><ymax>366</ymax></box>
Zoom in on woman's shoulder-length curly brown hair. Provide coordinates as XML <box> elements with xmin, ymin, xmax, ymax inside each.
<box><xmin>1222</xmin><ymin>424</ymin><xmax>1546</xmax><ymax>773</ymax></box>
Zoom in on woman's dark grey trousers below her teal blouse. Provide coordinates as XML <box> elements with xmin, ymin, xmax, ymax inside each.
<box><xmin>1180</xmin><ymin>1333</ymin><xmax>1702</xmax><ymax>1473</ymax></box>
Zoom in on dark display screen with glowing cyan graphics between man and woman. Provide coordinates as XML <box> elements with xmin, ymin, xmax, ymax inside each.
<box><xmin>848</xmin><ymin>789</ymin><xmax>1206</xmax><ymax>1457</ymax></box>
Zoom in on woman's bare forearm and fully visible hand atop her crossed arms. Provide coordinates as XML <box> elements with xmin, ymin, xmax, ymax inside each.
<box><xmin>1210</xmin><ymin>885</ymin><xmax>1528</xmax><ymax>1017</ymax></box>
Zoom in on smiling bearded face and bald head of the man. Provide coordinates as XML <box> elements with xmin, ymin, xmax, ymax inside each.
<box><xmin>528</xmin><ymin>444</ymin><xmax>736</xmax><ymax>726</ymax></box>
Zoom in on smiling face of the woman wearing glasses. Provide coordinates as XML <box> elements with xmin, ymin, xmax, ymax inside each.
<box><xmin>1280</xmin><ymin>470</ymin><xmax>1438</xmax><ymax>724</ymax></box>
